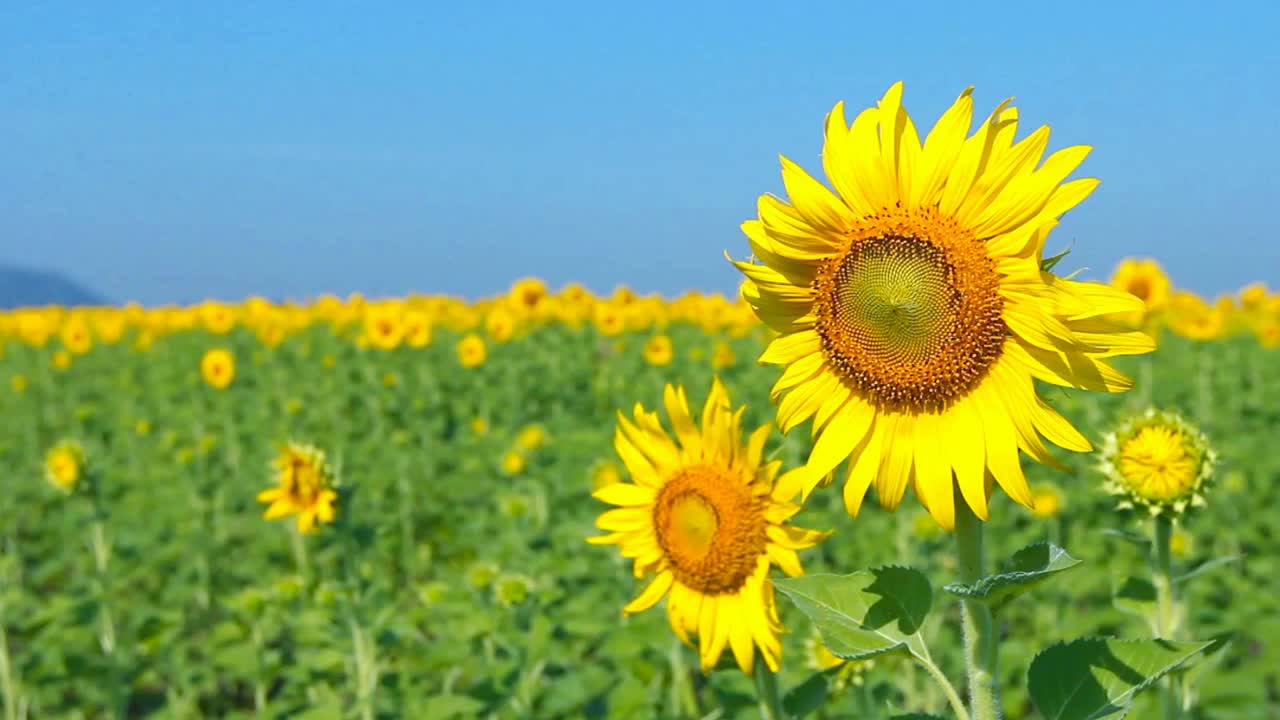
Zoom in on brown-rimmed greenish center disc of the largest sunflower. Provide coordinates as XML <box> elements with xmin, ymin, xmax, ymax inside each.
<box><xmin>813</xmin><ymin>204</ymin><xmax>1009</xmax><ymax>413</ymax></box>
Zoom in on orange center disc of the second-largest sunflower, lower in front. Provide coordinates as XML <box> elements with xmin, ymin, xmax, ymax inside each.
<box><xmin>653</xmin><ymin>465</ymin><xmax>767</xmax><ymax>594</ymax></box>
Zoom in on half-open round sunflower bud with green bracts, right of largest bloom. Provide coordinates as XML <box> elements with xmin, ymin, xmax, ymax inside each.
<box><xmin>1100</xmin><ymin>409</ymin><xmax>1217</xmax><ymax>515</ymax></box>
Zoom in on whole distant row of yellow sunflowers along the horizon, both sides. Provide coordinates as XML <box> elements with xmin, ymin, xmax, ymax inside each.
<box><xmin>0</xmin><ymin>259</ymin><xmax>1280</xmax><ymax>356</ymax></box>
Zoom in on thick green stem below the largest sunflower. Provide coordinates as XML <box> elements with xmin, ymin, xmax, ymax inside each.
<box><xmin>955</xmin><ymin>491</ymin><xmax>1004</xmax><ymax>720</ymax></box>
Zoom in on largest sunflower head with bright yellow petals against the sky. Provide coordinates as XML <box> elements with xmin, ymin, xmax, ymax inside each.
<box><xmin>735</xmin><ymin>83</ymin><xmax>1155</xmax><ymax>529</ymax></box>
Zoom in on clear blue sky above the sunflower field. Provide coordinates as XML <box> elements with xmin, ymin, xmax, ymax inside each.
<box><xmin>0</xmin><ymin>0</ymin><xmax>1280</xmax><ymax>302</ymax></box>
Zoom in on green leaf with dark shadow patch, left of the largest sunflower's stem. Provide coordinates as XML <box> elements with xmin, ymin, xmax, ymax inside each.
<box><xmin>773</xmin><ymin>566</ymin><xmax>933</xmax><ymax>660</ymax></box>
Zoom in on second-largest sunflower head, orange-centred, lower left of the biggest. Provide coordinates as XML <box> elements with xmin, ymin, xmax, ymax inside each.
<box><xmin>588</xmin><ymin>379</ymin><xmax>827</xmax><ymax>673</ymax></box>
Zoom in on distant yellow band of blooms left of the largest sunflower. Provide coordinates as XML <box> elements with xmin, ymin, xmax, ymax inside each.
<box><xmin>0</xmin><ymin>278</ymin><xmax>756</xmax><ymax>351</ymax></box>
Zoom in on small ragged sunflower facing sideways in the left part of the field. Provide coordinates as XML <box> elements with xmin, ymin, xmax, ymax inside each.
<box><xmin>257</xmin><ymin>441</ymin><xmax>338</xmax><ymax>533</ymax></box>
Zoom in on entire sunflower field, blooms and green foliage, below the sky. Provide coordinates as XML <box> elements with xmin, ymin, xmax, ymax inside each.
<box><xmin>0</xmin><ymin>87</ymin><xmax>1280</xmax><ymax>720</ymax></box>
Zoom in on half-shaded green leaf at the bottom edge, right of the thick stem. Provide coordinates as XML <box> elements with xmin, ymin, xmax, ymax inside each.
<box><xmin>1027</xmin><ymin>638</ymin><xmax>1213</xmax><ymax>720</ymax></box>
